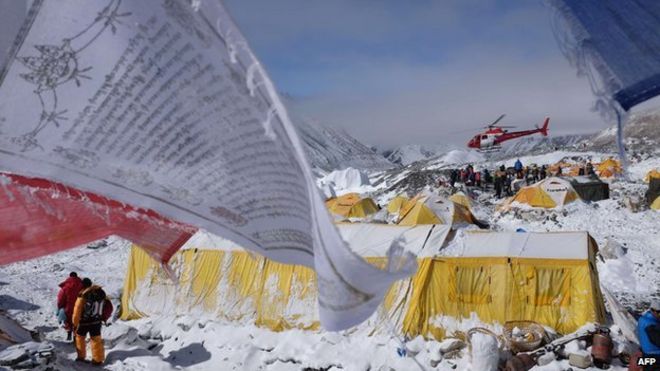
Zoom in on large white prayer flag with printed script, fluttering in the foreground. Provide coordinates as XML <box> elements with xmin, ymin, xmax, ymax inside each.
<box><xmin>0</xmin><ymin>0</ymin><xmax>416</xmax><ymax>330</ymax></box>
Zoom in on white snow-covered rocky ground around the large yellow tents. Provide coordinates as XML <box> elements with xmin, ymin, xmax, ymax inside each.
<box><xmin>0</xmin><ymin>152</ymin><xmax>660</xmax><ymax>371</ymax></box>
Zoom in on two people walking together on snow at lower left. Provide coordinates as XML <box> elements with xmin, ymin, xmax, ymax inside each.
<box><xmin>57</xmin><ymin>272</ymin><xmax>113</xmax><ymax>365</ymax></box>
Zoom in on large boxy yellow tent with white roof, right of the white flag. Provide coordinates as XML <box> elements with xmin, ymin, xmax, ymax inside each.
<box><xmin>403</xmin><ymin>232</ymin><xmax>605</xmax><ymax>339</ymax></box>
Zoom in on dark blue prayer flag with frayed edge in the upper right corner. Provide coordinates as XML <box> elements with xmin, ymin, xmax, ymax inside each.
<box><xmin>549</xmin><ymin>0</ymin><xmax>660</xmax><ymax>171</ymax></box>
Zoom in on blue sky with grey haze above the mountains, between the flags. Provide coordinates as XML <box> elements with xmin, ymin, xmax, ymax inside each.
<box><xmin>225</xmin><ymin>0</ymin><xmax>608</xmax><ymax>148</ymax></box>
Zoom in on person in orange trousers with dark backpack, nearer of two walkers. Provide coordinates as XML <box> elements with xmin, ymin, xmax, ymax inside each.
<box><xmin>72</xmin><ymin>278</ymin><xmax>113</xmax><ymax>365</ymax></box>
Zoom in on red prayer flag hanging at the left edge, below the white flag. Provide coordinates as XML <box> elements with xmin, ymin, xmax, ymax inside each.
<box><xmin>0</xmin><ymin>173</ymin><xmax>196</xmax><ymax>265</ymax></box>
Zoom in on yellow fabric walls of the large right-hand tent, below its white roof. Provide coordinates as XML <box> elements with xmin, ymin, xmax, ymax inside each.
<box><xmin>403</xmin><ymin>258</ymin><xmax>605</xmax><ymax>339</ymax></box>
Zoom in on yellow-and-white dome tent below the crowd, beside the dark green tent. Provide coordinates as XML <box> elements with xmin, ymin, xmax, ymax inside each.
<box><xmin>504</xmin><ymin>177</ymin><xmax>580</xmax><ymax>209</ymax></box>
